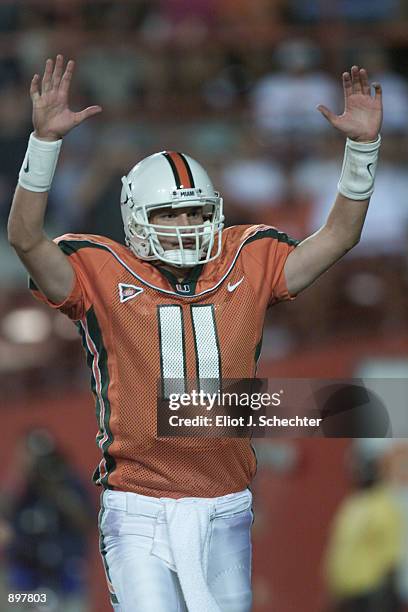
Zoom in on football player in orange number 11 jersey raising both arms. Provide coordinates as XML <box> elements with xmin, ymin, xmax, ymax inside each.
<box><xmin>8</xmin><ymin>55</ymin><xmax>382</xmax><ymax>612</ymax></box>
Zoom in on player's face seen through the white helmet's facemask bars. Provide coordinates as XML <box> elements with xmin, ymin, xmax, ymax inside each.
<box><xmin>149</xmin><ymin>206</ymin><xmax>204</xmax><ymax>250</ymax></box>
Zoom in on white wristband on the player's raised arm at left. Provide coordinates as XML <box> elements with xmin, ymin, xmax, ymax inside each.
<box><xmin>18</xmin><ymin>133</ymin><xmax>62</xmax><ymax>192</ymax></box>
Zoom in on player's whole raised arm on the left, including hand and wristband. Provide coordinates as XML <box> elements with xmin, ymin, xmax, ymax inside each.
<box><xmin>7</xmin><ymin>55</ymin><xmax>102</xmax><ymax>304</ymax></box>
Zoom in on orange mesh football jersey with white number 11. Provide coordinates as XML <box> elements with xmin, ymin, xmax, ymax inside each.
<box><xmin>31</xmin><ymin>226</ymin><xmax>296</xmax><ymax>498</ymax></box>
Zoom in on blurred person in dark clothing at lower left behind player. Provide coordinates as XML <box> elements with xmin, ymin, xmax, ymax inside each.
<box><xmin>0</xmin><ymin>428</ymin><xmax>96</xmax><ymax>612</ymax></box>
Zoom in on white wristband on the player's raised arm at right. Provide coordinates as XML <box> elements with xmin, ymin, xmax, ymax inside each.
<box><xmin>338</xmin><ymin>136</ymin><xmax>381</xmax><ymax>200</ymax></box>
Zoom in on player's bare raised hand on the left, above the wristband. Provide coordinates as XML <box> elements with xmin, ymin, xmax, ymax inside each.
<box><xmin>30</xmin><ymin>55</ymin><xmax>102</xmax><ymax>140</ymax></box>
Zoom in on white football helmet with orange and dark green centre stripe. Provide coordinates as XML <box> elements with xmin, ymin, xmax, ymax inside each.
<box><xmin>120</xmin><ymin>151</ymin><xmax>224</xmax><ymax>267</ymax></box>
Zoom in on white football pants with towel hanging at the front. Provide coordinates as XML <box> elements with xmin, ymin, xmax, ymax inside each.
<box><xmin>99</xmin><ymin>489</ymin><xmax>253</xmax><ymax>612</ymax></box>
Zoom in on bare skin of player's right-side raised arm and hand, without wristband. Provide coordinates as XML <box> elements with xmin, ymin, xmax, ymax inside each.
<box><xmin>285</xmin><ymin>66</ymin><xmax>382</xmax><ymax>295</ymax></box>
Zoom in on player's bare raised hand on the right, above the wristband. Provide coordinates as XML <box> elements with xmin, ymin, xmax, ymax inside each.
<box><xmin>317</xmin><ymin>66</ymin><xmax>382</xmax><ymax>142</ymax></box>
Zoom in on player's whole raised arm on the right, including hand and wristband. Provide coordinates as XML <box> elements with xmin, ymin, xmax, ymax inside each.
<box><xmin>285</xmin><ymin>66</ymin><xmax>382</xmax><ymax>294</ymax></box>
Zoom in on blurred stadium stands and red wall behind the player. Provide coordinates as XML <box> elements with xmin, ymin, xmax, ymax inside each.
<box><xmin>0</xmin><ymin>0</ymin><xmax>408</xmax><ymax>612</ymax></box>
